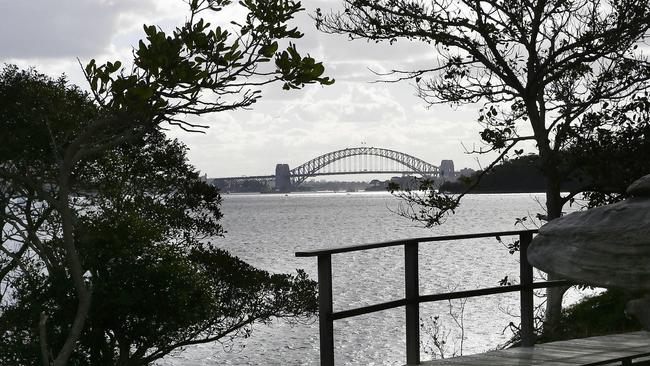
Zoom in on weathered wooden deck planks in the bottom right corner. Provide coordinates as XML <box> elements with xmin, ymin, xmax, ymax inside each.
<box><xmin>422</xmin><ymin>332</ymin><xmax>650</xmax><ymax>366</ymax></box>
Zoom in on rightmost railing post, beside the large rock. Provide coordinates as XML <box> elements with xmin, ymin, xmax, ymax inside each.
<box><xmin>519</xmin><ymin>232</ymin><xmax>535</xmax><ymax>347</ymax></box>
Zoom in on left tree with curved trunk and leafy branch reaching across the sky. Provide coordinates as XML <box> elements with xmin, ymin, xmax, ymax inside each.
<box><xmin>0</xmin><ymin>0</ymin><xmax>333</xmax><ymax>366</ymax></box>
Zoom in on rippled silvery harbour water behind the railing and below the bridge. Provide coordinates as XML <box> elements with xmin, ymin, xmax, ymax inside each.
<box><xmin>160</xmin><ymin>192</ymin><xmax>584</xmax><ymax>366</ymax></box>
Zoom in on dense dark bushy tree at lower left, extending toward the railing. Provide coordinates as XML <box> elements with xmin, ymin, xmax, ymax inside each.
<box><xmin>0</xmin><ymin>132</ymin><xmax>317</xmax><ymax>365</ymax></box>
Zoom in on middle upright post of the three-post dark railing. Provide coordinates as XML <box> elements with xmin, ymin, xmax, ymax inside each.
<box><xmin>404</xmin><ymin>241</ymin><xmax>420</xmax><ymax>365</ymax></box>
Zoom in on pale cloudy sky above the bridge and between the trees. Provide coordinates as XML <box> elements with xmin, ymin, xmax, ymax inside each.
<box><xmin>0</xmin><ymin>0</ymin><xmax>490</xmax><ymax>180</ymax></box>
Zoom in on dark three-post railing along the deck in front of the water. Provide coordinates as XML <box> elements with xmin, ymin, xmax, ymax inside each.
<box><xmin>296</xmin><ymin>230</ymin><xmax>569</xmax><ymax>366</ymax></box>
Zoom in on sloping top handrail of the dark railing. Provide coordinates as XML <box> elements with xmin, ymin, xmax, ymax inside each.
<box><xmin>296</xmin><ymin>229</ymin><xmax>537</xmax><ymax>257</ymax></box>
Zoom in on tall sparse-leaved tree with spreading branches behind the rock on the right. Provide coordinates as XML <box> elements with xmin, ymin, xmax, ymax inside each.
<box><xmin>316</xmin><ymin>0</ymin><xmax>650</xmax><ymax>332</ymax></box>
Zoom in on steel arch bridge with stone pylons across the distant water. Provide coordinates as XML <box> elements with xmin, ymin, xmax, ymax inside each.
<box><xmin>210</xmin><ymin>146</ymin><xmax>454</xmax><ymax>192</ymax></box>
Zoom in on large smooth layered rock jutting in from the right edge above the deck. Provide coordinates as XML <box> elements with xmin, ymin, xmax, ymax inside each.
<box><xmin>528</xmin><ymin>175</ymin><xmax>650</xmax><ymax>292</ymax></box>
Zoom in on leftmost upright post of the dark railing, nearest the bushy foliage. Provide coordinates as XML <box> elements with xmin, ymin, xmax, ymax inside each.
<box><xmin>318</xmin><ymin>254</ymin><xmax>334</xmax><ymax>366</ymax></box>
